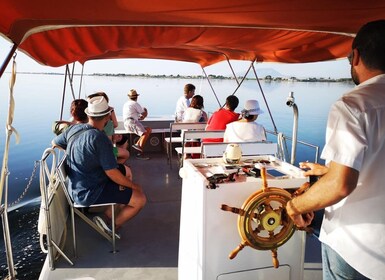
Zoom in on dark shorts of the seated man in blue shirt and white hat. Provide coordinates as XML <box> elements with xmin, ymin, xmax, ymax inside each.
<box><xmin>95</xmin><ymin>164</ymin><xmax>132</xmax><ymax>205</ymax></box>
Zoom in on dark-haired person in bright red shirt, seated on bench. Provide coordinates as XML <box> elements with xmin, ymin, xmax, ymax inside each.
<box><xmin>203</xmin><ymin>95</ymin><xmax>239</xmax><ymax>142</ymax></box>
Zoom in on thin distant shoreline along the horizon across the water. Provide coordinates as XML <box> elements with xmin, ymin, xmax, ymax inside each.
<box><xmin>9</xmin><ymin>72</ymin><xmax>352</xmax><ymax>83</ymax></box>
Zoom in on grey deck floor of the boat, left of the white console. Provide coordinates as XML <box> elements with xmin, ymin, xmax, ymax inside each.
<box><xmin>39</xmin><ymin>153</ymin><xmax>322</xmax><ymax>280</ymax></box>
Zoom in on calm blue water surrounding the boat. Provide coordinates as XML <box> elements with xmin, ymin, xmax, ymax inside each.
<box><xmin>0</xmin><ymin>74</ymin><xmax>353</xmax><ymax>279</ymax></box>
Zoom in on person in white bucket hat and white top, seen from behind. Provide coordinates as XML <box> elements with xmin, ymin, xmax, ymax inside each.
<box><xmin>223</xmin><ymin>100</ymin><xmax>266</xmax><ymax>142</ymax></box>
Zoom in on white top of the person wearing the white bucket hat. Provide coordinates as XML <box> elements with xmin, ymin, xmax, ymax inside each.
<box><xmin>223</xmin><ymin>121</ymin><xmax>266</xmax><ymax>142</ymax></box>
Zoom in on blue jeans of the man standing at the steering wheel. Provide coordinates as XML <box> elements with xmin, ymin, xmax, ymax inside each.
<box><xmin>322</xmin><ymin>243</ymin><xmax>370</xmax><ymax>280</ymax></box>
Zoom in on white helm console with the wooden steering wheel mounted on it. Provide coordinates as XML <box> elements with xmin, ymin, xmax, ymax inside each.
<box><xmin>178</xmin><ymin>156</ymin><xmax>307</xmax><ymax>280</ymax></box>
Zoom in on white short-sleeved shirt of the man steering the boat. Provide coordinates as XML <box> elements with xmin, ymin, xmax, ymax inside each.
<box><xmin>320</xmin><ymin>75</ymin><xmax>385</xmax><ymax>279</ymax></box>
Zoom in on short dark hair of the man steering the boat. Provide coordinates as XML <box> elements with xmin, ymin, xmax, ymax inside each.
<box><xmin>352</xmin><ymin>20</ymin><xmax>385</xmax><ymax>71</ymax></box>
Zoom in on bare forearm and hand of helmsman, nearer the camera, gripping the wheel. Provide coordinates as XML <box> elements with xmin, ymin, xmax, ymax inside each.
<box><xmin>286</xmin><ymin>161</ymin><xmax>359</xmax><ymax>227</ymax></box>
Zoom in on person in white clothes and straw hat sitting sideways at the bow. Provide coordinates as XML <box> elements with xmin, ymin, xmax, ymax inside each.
<box><xmin>123</xmin><ymin>89</ymin><xmax>152</xmax><ymax>160</ymax></box>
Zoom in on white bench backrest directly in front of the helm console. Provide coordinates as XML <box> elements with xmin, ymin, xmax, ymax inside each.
<box><xmin>201</xmin><ymin>142</ymin><xmax>277</xmax><ymax>158</ymax></box>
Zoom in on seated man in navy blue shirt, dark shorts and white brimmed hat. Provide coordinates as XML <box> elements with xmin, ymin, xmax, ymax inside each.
<box><xmin>52</xmin><ymin>96</ymin><xmax>146</xmax><ymax>234</ymax></box>
